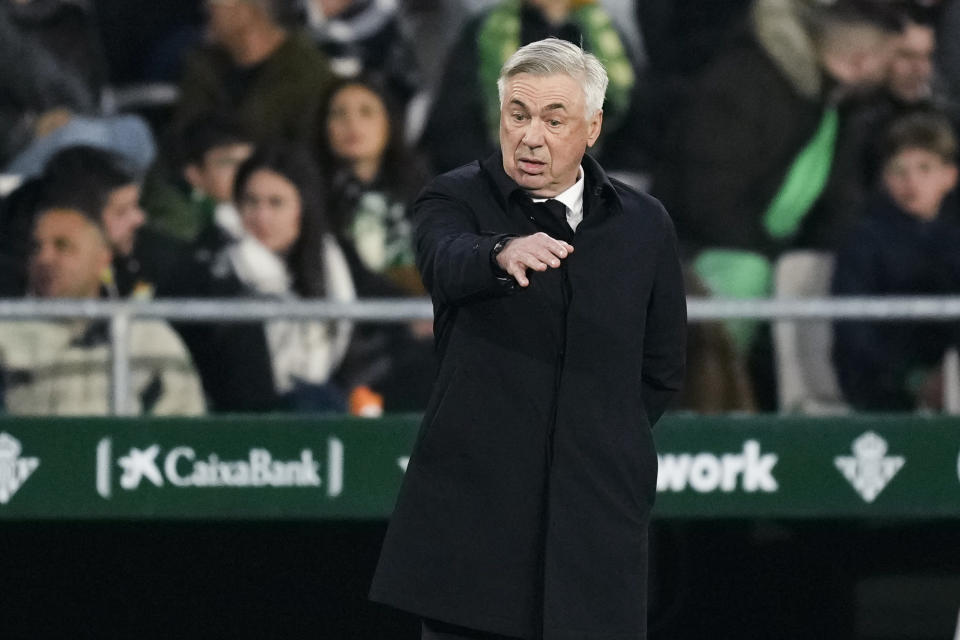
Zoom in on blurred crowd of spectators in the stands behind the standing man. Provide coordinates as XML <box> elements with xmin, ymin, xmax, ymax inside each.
<box><xmin>0</xmin><ymin>0</ymin><xmax>960</xmax><ymax>415</ymax></box>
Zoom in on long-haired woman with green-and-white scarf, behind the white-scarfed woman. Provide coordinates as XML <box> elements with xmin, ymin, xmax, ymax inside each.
<box><xmin>323</xmin><ymin>79</ymin><xmax>433</xmax><ymax>411</ymax></box>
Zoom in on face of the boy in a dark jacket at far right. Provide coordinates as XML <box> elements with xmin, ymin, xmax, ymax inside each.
<box><xmin>883</xmin><ymin>148</ymin><xmax>957</xmax><ymax>220</ymax></box>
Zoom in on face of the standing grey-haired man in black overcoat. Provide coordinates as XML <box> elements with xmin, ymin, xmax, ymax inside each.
<box><xmin>500</xmin><ymin>73</ymin><xmax>603</xmax><ymax>198</ymax></box>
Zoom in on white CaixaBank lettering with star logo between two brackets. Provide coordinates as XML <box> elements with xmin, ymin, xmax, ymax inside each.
<box><xmin>96</xmin><ymin>437</ymin><xmax>343</xmax><ymax>499</ymax></box>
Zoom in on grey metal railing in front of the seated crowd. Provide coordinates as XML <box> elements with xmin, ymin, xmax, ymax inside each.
<box><xmin>0</xmin><ymin>296</ymin><xmax>960</xmax><ymax>415</ymax></box>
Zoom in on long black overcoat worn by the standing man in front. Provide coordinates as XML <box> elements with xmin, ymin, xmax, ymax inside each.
<box><xmin>371</xmin><ymin>154</ymin><xmax>686</xmax><ymax>640</ymax></box>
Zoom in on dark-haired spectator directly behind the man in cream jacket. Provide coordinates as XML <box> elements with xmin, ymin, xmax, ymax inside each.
<box><xmin>0</xmin><ymin>147</ymin><xmax>184</xmax><ymax>298</ymax></box>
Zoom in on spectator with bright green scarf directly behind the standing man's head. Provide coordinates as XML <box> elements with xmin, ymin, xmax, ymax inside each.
<box><xmin>422</xmin><ymin>0</ymin><xmax>635</xmax><ymax>172</ymax></box>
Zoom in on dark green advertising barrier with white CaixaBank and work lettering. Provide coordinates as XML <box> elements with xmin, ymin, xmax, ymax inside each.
<box><xmin>0</xmin><ymin>416</ymin><xmax>960</xmax><ymax>520</ymax></box>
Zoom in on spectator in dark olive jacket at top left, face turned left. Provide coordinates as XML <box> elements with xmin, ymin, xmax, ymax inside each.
<box><xmin>173</xmin><ymin>0</ymin><xmax>333</xmax><ymax>148</ymax></box>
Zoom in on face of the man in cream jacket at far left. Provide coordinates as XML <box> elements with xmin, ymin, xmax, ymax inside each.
<box><xmin>29</xmin><ymin>209</ymin><xmax>111</xmax><ymax>298</ymax></box>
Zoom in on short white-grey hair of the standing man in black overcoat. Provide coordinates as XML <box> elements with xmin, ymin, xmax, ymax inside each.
<box><xmin>497</xmin><ymin>38</ymin><xmax>609</xmax><ymax>119</ymax></box>
